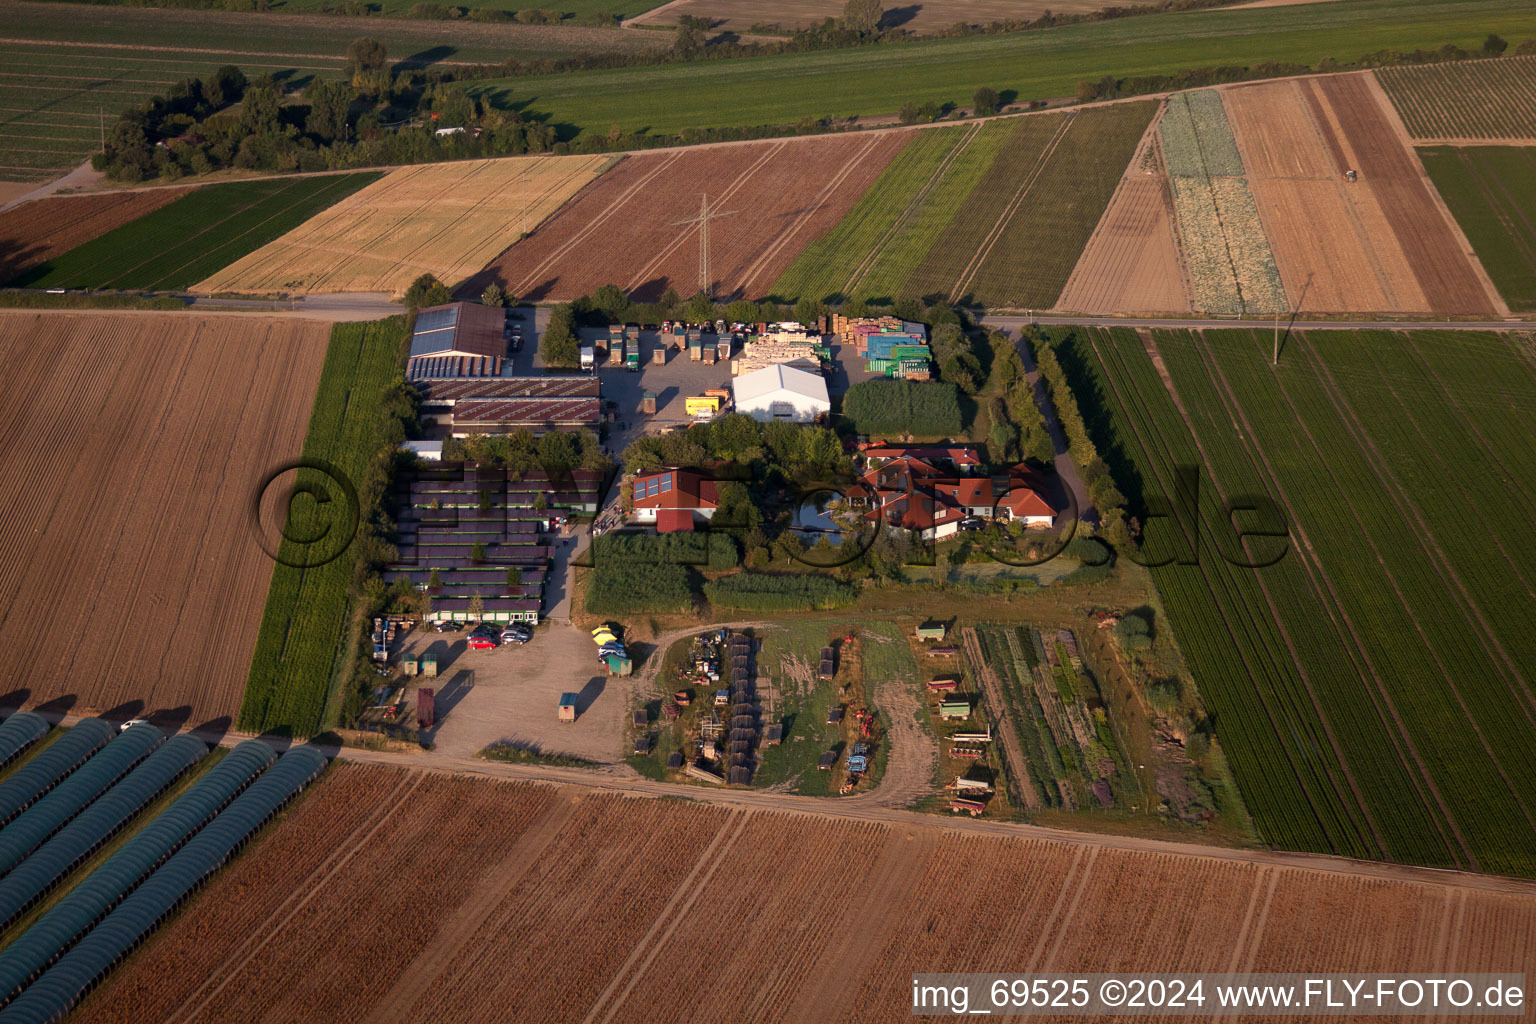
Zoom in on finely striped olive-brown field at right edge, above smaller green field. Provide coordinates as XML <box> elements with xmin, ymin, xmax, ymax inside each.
<box><xmin>1376</xmin><ymin>57</ymin><xmax>1536</xmax><ymax>138</ymax></box>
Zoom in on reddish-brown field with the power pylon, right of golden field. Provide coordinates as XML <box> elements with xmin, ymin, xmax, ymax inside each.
<box><xmin>473</xmin><ymin>132</ymin><xmax>912</xmax><ymax>301</ymax></box>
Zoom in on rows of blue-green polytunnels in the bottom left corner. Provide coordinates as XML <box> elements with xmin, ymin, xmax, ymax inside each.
<box><xmin>0</xmin><ymin>712</ymin><xmax>327</xmax><ymax>1022</ymax></box>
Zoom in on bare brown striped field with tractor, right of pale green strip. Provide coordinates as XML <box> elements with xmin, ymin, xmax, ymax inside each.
<box><xmin>1223</xmin><ymin>75</ymin><xmax>1507</xmax><ymax>313</ymax></box>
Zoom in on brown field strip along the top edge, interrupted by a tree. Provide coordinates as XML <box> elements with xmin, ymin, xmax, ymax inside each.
<box><xmin>627</xmin><ymin>0</ymin><xmax>1111</xmax><ymax>34</ymax></box>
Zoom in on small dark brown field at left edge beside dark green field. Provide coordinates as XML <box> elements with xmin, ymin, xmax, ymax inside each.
<box><xmin>0</xmin><ymin>189</ymin><xmax>189</xmax><ymax>284</ymax></box>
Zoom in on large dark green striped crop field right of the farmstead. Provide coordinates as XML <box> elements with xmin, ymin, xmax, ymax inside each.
<box><xmin>1058</xmin><ymin>330</ymin><xmax>1536</xmax><ymax>875</ymax></box>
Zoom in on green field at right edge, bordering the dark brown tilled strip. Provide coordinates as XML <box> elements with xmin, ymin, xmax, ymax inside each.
<box><xmin>1419</xmin><ymin>146</ymin><xmax>1536</xmax><ymax>312</ymax></box>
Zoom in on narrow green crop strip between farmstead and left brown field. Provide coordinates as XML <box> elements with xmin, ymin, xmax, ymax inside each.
<box><xmin>240</xmin><ymin>316</ymin><xmax>410</xmax><ymax>735</ymax></box>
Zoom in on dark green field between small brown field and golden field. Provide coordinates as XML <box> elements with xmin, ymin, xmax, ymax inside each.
<box><xmin>17</xmin><ymin>170</ymin><xmax>379</xmax><ymax>292</ymax></box>
